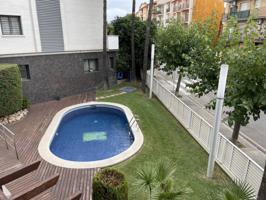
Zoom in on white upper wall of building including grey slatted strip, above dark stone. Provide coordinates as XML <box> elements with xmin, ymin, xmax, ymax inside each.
<box><xmin>0</xmin><ymin>0</ymin><xmax>103</xmax><ymax>55</ymax></box>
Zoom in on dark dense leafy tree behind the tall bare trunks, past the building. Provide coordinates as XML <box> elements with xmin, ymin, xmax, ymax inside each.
<box><xmin>110</xmin><ymin>15</ymin><xmax>156</xmax><ymax>79</ymax></box>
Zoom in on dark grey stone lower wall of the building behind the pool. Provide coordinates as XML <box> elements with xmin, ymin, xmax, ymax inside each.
<box><xmin>0</xmin><ymin>52</ymin><xmax>116</xmax><ymax>103</ymax></box>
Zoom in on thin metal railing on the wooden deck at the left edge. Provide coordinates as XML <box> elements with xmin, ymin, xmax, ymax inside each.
<box><xmin>0</xmin><ymin>123</ymin><xmax>19</xmax><ymax>159</ymax></box>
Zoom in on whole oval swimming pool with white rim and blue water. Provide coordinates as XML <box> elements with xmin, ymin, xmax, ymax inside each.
<box><xmin>38</xmin><ymin>102</ymin><xmax>143</xmax><ymax>168</ymax></box>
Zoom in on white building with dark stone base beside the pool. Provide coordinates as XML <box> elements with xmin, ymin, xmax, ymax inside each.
<box><xmin>0</xmin><ymin>0</ymin><xmax>118</xmax><ymax>103</ymax></box>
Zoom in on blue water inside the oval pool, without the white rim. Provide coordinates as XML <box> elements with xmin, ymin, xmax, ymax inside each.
<box><xmin>50</xmin><ymin>106</ymin><xmax>134</xmax><ymax>162</ymax></box>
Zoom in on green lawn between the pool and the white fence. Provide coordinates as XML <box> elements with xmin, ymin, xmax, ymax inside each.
<box><xmin>96</xmin><ymin>82</ymin><xmax>231</xmax><ymax>200</ymax></box>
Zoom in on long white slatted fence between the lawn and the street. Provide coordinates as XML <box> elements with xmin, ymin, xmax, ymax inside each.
<box><xmin>147</xmin><ymin>72</ymin><xmax>264</xmax><ymax>193</ymax></box>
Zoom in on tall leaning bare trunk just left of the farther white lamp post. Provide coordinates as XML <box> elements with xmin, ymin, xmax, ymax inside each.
<box><xmin>142</xmin><ymin>0</ymin><xmax>153</xmax><ymax>93</ymax></box>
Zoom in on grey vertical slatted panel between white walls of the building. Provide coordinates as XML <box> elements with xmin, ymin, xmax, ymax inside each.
<box><xmin>36</xmin><ymin>0</ymin><xmax>64</xmax><ymax>52</ymax></box>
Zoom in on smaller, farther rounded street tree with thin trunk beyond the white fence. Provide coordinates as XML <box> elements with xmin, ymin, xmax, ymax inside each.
<box><xmin>156</xmin><ymin>20</ymin><xmax>198</xmax><ymax>95</ymax></box>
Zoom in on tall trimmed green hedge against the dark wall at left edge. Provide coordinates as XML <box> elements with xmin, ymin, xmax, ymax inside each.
<box><xmin>0</xmin><ymin>64</ymin><xmax>23</xmax><ymax>117</ymax></box>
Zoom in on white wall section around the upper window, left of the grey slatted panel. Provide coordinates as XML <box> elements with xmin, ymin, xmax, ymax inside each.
<box><xmin>0</xmin><ymin>0</ymin><xmax>41</xmax><ymax>55</ymax></box>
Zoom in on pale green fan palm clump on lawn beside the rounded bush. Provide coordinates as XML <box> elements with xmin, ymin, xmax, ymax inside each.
<box><xmin>135</xmin><ymin>161</ymin><xmax>189</xmax><ymax>200</ymax></box>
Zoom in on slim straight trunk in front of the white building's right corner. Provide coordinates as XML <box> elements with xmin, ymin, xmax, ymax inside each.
<box><xmin>103</xmin><ymin>0</ymin><xmax>110</xmax><ymax>89</ymax></box>
